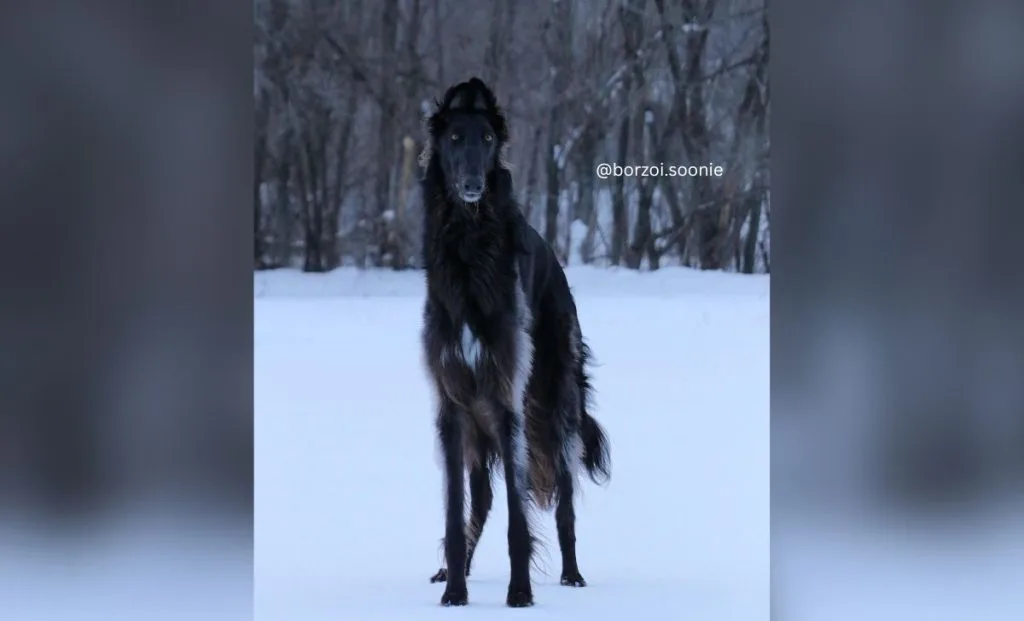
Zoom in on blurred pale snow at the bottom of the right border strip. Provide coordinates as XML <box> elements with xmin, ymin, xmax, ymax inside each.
<box><xmin>772</xmin><ymin>500</ymin><xmax>1024</xmax><ymax>621</ymax></box>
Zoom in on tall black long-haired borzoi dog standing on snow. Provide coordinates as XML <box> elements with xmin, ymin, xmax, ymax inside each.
<box><xmin>422</xmin><ymin>78</ymin><xmax>610</xmax><ymax>607</ymax></box>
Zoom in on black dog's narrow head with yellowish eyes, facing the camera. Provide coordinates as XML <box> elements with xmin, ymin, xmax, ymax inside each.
<box><xmin>427</xmin><ymin>78</ymin><xmax>508</xmax><ymax>204</ymax></box>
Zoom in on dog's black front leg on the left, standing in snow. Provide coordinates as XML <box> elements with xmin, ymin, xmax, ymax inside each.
<box><xmin>437</xmin><ymin>397</ymin><xmax>469</xmax><ymax>606</ymax></box>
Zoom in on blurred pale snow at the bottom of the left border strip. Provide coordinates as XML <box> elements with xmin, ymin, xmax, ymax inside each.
<box><xmin>0</xmin><ymin>510</ymin><xmax>252</xmax><ymax>621</ymax></box>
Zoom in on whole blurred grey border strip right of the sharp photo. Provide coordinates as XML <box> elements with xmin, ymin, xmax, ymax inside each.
<box><xmin>770</xmin><ymin>0</ymin><xmax>1024</xmax><ymax>621</ymax></box>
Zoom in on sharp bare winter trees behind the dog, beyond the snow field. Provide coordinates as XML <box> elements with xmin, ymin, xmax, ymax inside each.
<box><xmin>254</xmin><ymin>0</ymin><xmax>770</xmax><ymax>273</ymax></box>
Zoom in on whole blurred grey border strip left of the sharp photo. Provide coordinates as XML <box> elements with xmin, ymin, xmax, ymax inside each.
<box><xmin>0</xmin><ymin>0</ymin><xmax>253</xmax><ymax>619</ymax></box>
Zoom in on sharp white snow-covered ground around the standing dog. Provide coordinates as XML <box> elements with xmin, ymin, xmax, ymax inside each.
<box><xmin>254</xmin><ymin>267</ymin><xmax>770</xmax><ymax>621</ymax></box>
